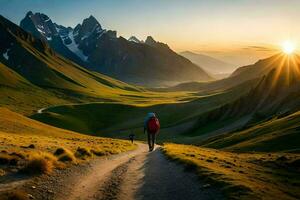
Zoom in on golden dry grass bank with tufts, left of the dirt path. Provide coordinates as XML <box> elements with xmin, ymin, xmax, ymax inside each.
<box><xmin>0</xmin><ymin>108</ymin><xmax>136</xmax><ymax>179</ymax></box>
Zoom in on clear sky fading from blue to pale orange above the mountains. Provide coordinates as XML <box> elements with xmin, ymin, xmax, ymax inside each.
<box><xmin>0</xmin><ymin>0</ymin><xmax>300</xmax><ymax>64</ymax></box>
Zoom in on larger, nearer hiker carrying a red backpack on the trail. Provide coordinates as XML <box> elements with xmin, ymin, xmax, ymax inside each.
<box><xmin>144</xmin><ymin>113</ymin><xmax>160</xmax><ymax>151</ymax></box>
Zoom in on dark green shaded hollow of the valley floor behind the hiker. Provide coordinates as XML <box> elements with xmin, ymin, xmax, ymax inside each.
<box><xmin>32</xmin><ymin>79</ymin><xmax>249</xmax><ymax>137</ymax></box>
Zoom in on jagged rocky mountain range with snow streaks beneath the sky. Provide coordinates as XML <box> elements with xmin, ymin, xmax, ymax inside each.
<box><xmin>20</xmin><ymin>11</ymin><xmax>213</xmax><ymax>87</ymax></box>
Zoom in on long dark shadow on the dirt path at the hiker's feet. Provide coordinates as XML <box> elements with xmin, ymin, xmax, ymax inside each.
<box><xmin>135</xmin><ymin>147</ymin><xmax>218</xmax><ymax>200</ymax></box>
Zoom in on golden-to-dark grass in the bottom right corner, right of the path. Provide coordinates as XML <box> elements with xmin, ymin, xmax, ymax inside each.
<box><xmin>164</xmin><ymin>144</ymin><xmax>300</xmax><ymax>200</ymax></box>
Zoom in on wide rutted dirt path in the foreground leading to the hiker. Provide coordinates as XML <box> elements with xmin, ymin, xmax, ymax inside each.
<box><xmin>22</xmin><ymin>144</ymin><xmax>222</xmax><ymax>200</ymax></box>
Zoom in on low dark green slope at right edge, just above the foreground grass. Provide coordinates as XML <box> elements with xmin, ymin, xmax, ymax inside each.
<box><xmin>202</xmin><ymin>112</ymin><xmax>300</xmax><ymax>152</ymax></box>
